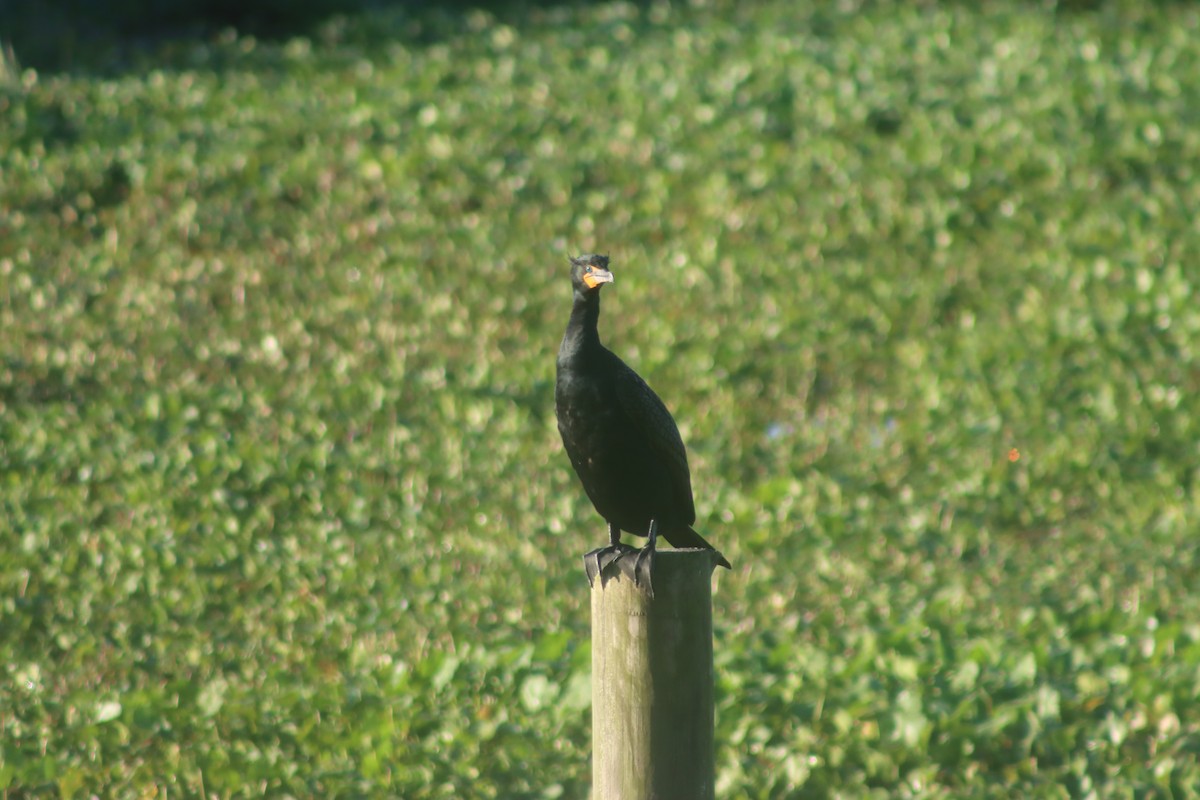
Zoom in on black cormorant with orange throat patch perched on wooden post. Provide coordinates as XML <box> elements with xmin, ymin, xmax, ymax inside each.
<box><xmin>554</xmin><ymin>255</ymin><xmax>730</xmax><ymax>594</ymax></box>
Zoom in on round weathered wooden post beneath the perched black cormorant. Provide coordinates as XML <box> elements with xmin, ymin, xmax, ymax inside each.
<box><xmin>592</xmin><ymin>549</ymin><xmax>716</xmax><ymax>800</ymax></box>
